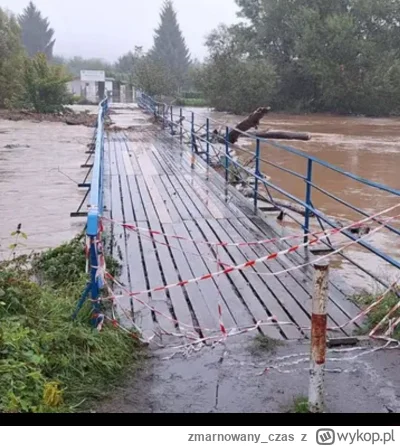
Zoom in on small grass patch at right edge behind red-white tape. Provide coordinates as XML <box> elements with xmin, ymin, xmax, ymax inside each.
<box><xmin>353</xmin><ymin>293</ymin><xmax>400</xmax><ymax>340</ymax></box>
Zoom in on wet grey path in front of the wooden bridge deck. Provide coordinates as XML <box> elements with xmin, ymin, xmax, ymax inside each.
<box><xmin>97</xmin><ymin>337</ymin><xmax>400</xmax><ymax>413</ymax></box>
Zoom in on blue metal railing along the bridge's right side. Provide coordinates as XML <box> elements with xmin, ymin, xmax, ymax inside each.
<box><xmin>138</xmin><ymin>93</ymin><xmax>400</xmax><ymax>285</ymax></box>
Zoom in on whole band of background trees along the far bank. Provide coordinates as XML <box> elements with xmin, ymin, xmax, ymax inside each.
<box><xmin>0</xmin><ymin>0</ymin><xmax>400</xmax><ymax>116</ymax></box>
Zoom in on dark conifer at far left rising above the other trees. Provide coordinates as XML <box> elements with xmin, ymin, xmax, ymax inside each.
<box><xmin>18</xmin><ymin>2</ymin><xmax>55</xmax><ymax>59</ymax></box>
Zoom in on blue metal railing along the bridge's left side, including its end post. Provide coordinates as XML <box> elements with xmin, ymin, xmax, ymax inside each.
<box><xmin>73</xmin><ymin>99</ymin><xmax>108</xmax><ymax>327</ymax></box>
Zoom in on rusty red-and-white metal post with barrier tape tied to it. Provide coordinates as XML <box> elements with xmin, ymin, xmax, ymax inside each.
<box><xmin>308</xmin><ymin>262</ymin><xmax>329</xmax><ymax>413</ymax></box>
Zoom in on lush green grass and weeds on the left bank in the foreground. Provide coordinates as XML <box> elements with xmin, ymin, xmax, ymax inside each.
<box><xmin>0</xmin><ymin>233</ymin><xmax>141</xmax><ymax>413</ymax></box>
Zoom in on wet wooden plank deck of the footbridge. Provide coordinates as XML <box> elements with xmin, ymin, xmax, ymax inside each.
<box><xmin>105</xmin><ymin>106</ymin><xmax>359</xmax><ymax>340</ymax></box>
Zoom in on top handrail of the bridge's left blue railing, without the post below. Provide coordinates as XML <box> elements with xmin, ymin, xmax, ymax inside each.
<box><xmin>86</xmin><ymin>99</ymin><xmax>108</xmax><ymax>237</ymax></box>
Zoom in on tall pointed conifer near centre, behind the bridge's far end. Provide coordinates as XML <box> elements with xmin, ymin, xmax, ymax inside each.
<box><xmin>150</xmin><ymin>0</ymin><xmax>190</xmax><ymax>90</ymax></box>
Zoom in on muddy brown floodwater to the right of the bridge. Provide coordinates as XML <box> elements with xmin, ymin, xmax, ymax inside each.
<box><xmin>188</xmin><ymin>109</ymin><xmax>400</xmax><ymax>289</ymax></box>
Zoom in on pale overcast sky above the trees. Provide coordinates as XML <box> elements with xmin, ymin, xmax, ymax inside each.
<box><xmin>0</xmin><ymin>0</ymin><xmax>237</xmax><ymax>61</ymax></box>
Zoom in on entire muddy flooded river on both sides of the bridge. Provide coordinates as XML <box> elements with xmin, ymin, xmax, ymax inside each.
<box><xmin>0</xmin><ymin>109</ymin><xmax>400</xmax><ymax>288</ymax></box>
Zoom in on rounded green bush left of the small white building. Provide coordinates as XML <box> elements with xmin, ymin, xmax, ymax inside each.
<box><xmin>22</xmin><ymin>53</ymin><xmax>71</xmax><ymax>113</ymax></box>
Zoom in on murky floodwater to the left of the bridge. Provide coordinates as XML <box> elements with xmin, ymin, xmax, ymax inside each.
<box><xmin>0</xmin><ymin>116</ymin><xmax>93</xmax><ymax>259</ymax></box>
